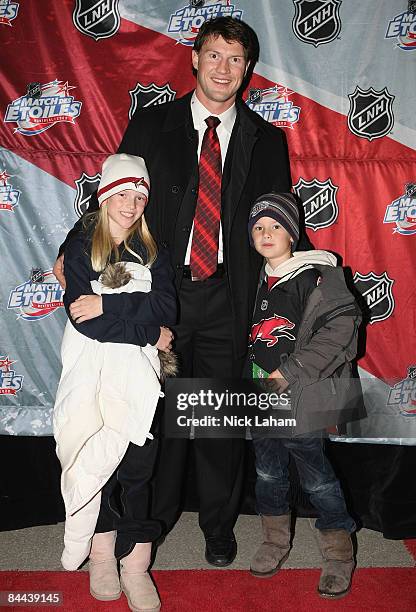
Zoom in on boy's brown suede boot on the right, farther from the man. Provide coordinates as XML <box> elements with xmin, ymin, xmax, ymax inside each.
<box><xmin>318</xmin><ymin>529</ymin><xmax>355</xmax><ymax>599</ymax></box>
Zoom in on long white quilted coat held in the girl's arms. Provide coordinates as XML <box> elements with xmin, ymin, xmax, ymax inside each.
<box><xmin>54</xmin><ymin>262</ymin><xmax>160</xmax><ymax>570</ymax></box>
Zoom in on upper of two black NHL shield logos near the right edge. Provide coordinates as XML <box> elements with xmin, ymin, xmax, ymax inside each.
<box><xmin>348</xmin><ymin>85</ymin><xmax>394</xmax><ymax>140</ymax></box>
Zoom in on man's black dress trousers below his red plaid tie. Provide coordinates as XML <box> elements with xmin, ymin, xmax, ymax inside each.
<box><xmin>152</xmin><ymin>277</ymin><xmax>245</xmax><ymax>536</ymax></box>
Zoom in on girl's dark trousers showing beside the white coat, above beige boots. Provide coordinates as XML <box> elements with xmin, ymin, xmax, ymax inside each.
<box><xmin>95</xmin><ymin>440</ymin><xmax>161</xmax><ymax>559</ymax></box>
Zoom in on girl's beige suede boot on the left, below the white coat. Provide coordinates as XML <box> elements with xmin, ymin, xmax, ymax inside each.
<box><xmin>88</xmin><ymin>531</ymin><xmax>121</xmax><ymax>601</ymax></box>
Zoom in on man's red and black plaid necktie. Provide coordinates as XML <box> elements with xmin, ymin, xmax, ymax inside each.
<box><xmin>190</xmin><ymin>117</ymin><xmax>222</xmax><ymax>280</ymax></box>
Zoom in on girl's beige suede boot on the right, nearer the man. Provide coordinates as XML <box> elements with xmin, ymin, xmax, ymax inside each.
<box><xmin>120</xmin><ymin>542</ymin><xmax>160</xmax><ymax>612</ymax></box>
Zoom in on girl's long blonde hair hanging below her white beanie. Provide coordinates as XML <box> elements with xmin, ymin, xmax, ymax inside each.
<box><xmin>84</xmin><ymin>205</ymin><xmax>157</xmax><ymax>272</ymax></box>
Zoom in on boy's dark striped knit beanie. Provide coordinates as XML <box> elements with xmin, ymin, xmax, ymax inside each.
<box><xmin>248</xmin><ymin>193</ymin><xmax>299</xmax><ymax>250</ymax></box>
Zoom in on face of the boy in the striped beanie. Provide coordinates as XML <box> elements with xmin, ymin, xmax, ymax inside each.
<box><xmin>251</xmin><ymin>217</ymin><xmax>293</xmax><ymax>268</ymax></box>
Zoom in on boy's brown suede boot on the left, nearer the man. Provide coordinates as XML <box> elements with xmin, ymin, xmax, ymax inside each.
<box><xmin>250</xmin><ymin>514</ymin><xmax>290</xmax><ymax>578</ymax></box>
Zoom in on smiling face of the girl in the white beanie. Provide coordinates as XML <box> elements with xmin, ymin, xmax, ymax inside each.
<box><xmin>103</xmin><ymin>189</ymin><xmax>147</xmax><ymax>241</ymax></box>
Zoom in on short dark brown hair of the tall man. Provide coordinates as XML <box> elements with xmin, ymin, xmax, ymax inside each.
<box><xmin>193</xmin><ymin>17</ymin><xmax>259</xmax><ymax>70</ymax></box>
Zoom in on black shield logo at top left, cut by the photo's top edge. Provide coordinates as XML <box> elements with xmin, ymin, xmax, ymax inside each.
<box><xmin>72</xmin><ymin>0</ymin><xmax>120</xmax><ymax>40</ymax></box>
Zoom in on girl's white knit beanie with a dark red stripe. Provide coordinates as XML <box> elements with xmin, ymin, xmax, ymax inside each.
<box><xmin>97</xmin><ymin>153</ymin><xmax>150</xmax><ymax>206</ymax></box>
